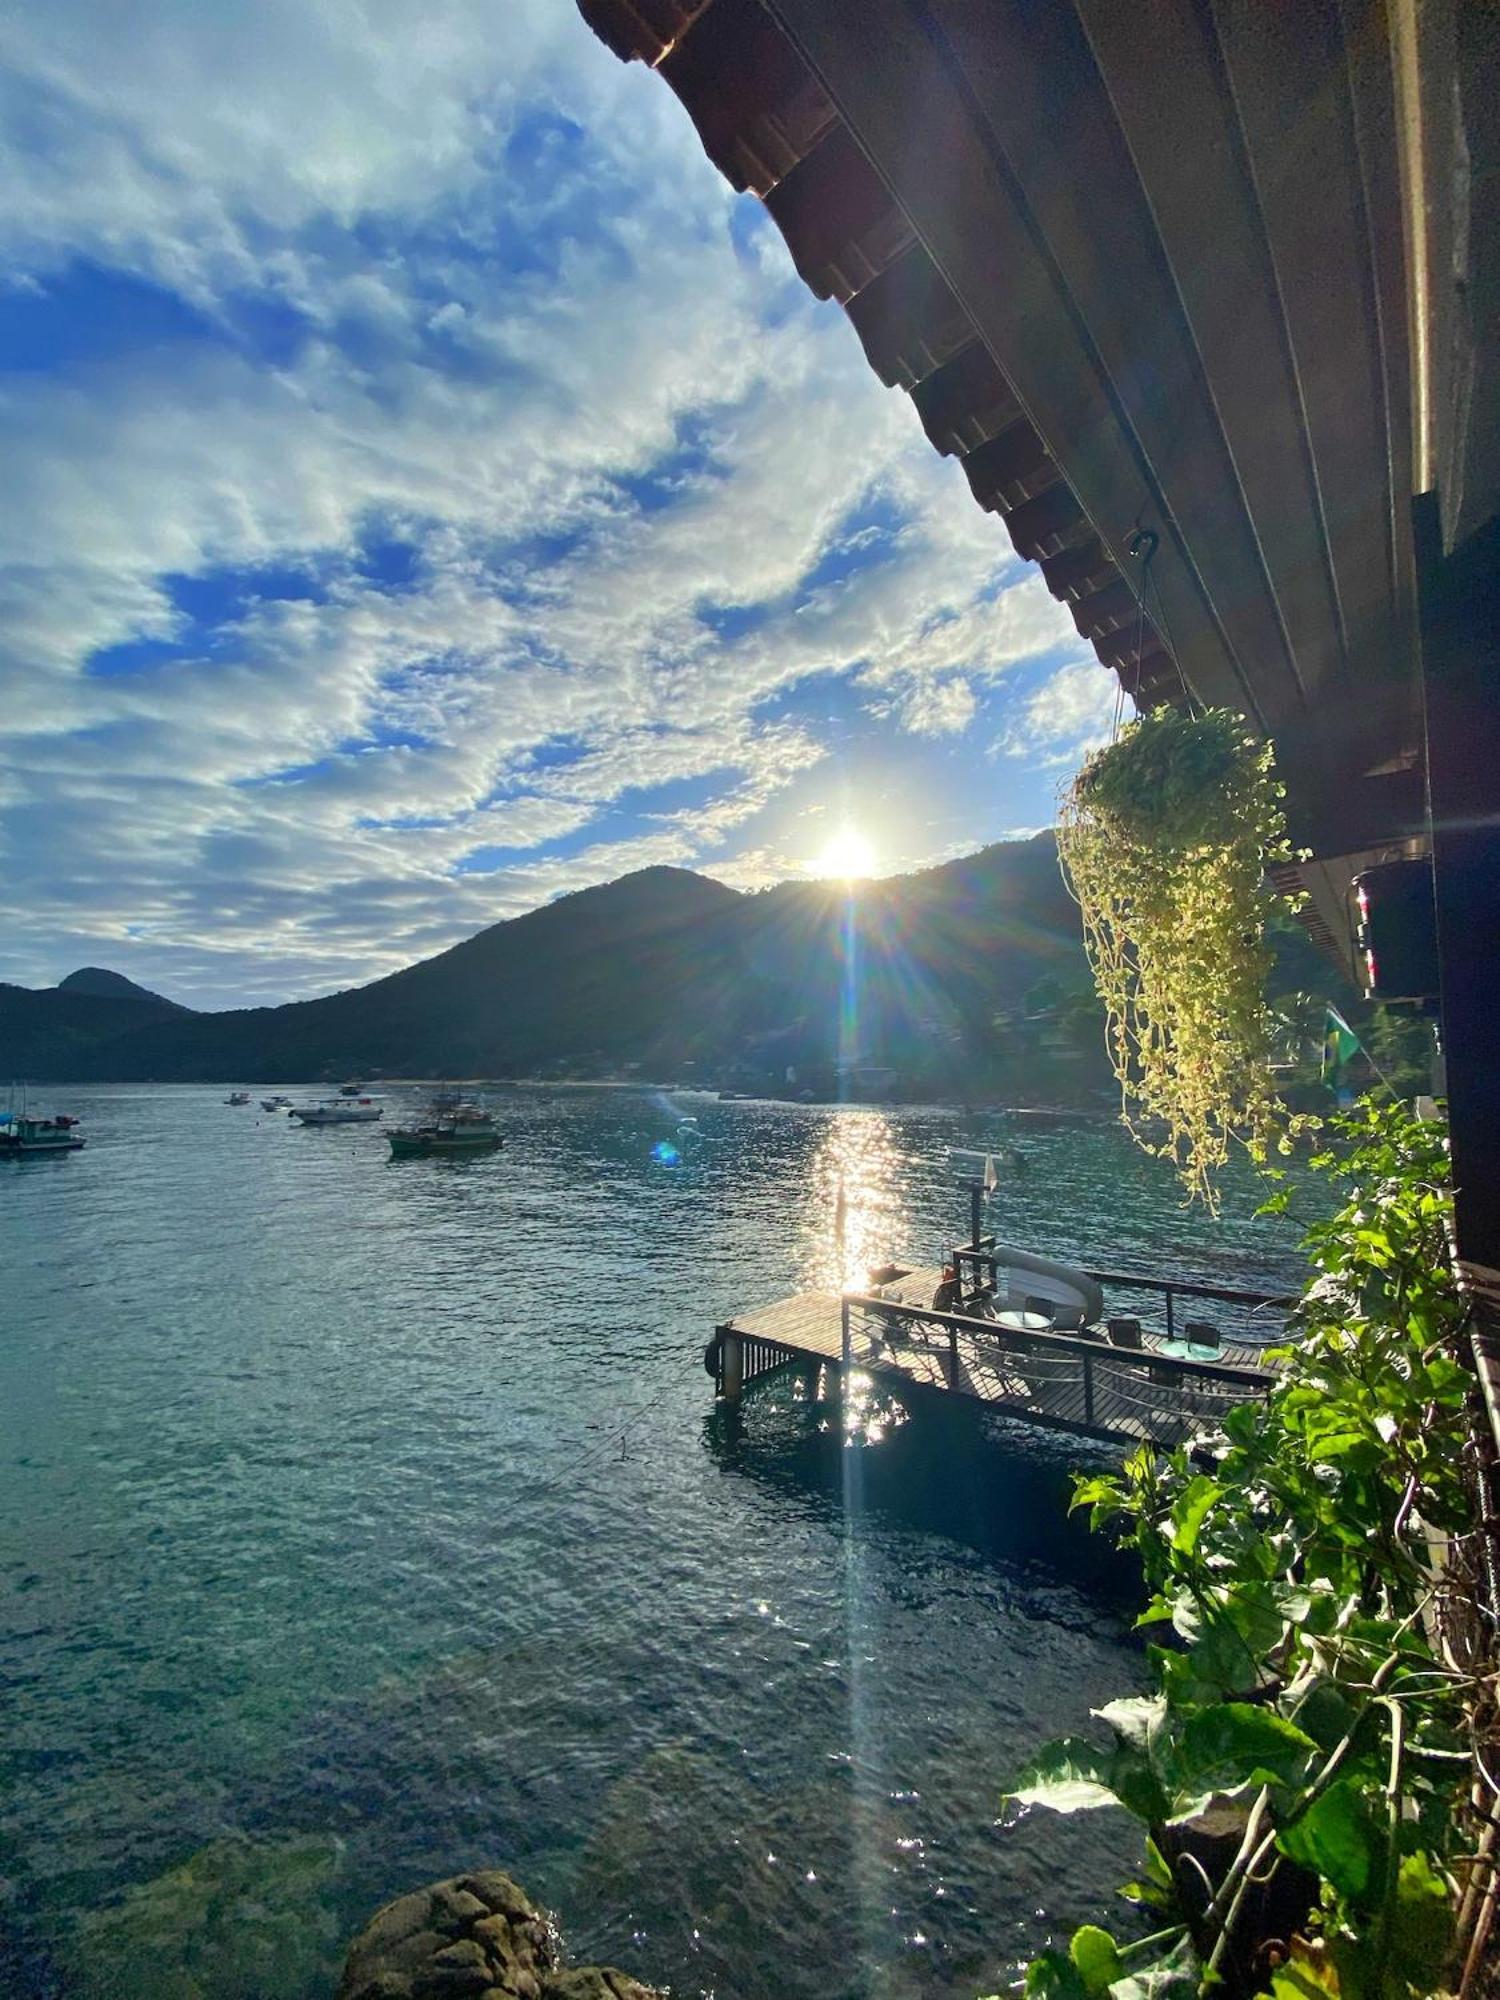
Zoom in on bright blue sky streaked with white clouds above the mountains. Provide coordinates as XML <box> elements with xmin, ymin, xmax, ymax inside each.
<box><xmin>0</xmin><ymin>0</ymin><xmax>1116</xmax><ymax>1006</ymax></box>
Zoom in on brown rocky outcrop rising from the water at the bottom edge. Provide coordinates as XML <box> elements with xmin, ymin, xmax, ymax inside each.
<box><xmin>338</xmin><ymin>1868</ymin><xmax>660</xmax><ymax>2000</ymax></box>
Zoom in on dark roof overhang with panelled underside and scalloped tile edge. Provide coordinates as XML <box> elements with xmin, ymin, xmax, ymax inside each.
<box><xmin>578</xmin><ymin>0</ymin><xmax>1492</xmax><ymax>968</ymax></box>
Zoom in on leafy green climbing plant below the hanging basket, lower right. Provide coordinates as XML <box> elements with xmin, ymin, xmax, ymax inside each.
<box><xmin>1014</xmin><ymin>1102</ymin><xmax>1476</xmax><ymax>2000</ymax></box>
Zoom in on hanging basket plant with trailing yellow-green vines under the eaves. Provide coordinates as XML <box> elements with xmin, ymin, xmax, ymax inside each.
<box><xmin>1058</xmin><ymin>708</ymin><xmax>1298</xmax><ymax>1210</ymax></box>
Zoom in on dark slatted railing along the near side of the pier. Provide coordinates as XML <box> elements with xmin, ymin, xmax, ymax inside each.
<box><xmin>840</xmin><ymin>1294</ymin><xmax>1272</xmax><ymax>1444</ymax></box>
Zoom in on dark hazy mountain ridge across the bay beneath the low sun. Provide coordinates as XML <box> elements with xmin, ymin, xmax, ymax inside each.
<box><xmin>0</xmin><ymin>836</ymin><xmax>1084</xmax><ymax>1088</ymax></box>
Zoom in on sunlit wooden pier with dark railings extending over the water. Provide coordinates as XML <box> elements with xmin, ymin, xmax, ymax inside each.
<box><xmin>716</xmin><ymin>1268</ymin><xmax>1286</xmax><ymax>1446</ymax></box>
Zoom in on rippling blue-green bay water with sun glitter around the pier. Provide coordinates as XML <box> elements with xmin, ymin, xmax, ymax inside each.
<box><xmin>0</xmin><ymin>1086</ymin><xmax>1294</xmax><ymax>2000</ymax></box>
